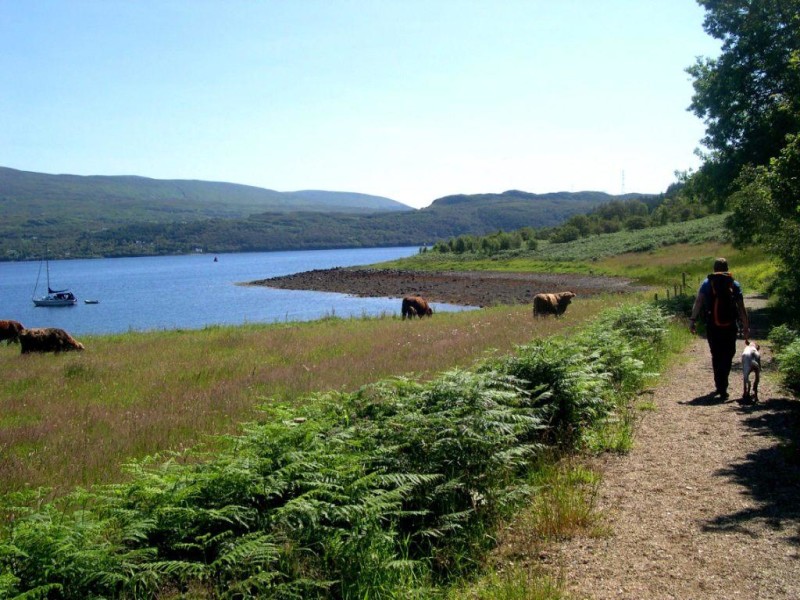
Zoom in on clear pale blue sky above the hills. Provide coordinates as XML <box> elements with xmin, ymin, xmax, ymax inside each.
<box><xmin>0</xmin><ymin>0</ymin><xmax>719</xmax><ymax>207</ymax></box>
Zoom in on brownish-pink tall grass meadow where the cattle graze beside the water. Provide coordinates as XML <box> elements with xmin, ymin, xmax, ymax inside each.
<box><xmin>0</xmin><ymin>298</ymin><xmax>617</xmax><ymax>492</ymax></box>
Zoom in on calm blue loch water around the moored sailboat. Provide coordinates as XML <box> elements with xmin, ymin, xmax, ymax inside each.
<box><xmin>0</xmin><ymin>247</ymin><xmax>468</xmax><ymax>335</ymax></box>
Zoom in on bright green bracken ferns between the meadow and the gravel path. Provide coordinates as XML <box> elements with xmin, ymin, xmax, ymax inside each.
<box><xmin>0</xmin><ymin>306</ymin><xmax>666</xmax><ymax>599</ymax></box>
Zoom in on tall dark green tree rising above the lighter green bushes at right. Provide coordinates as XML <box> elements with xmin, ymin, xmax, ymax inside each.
<box><xmin>687</xmin><ymin>0</ymin><xmax>800</xmax><ymax>205</ymax></box>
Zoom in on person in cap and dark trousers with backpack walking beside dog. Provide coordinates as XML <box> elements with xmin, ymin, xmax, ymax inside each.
<box><xmin>689</xmin><ymin>258</ymin><xmax>750</xmax><ymax>401</ymax></box>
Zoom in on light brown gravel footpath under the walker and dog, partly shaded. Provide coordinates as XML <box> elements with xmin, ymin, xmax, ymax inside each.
<box><xmin>550</xmin><ymin>298</ymin><xmax>800</xmax><ymax>600</ymax></box>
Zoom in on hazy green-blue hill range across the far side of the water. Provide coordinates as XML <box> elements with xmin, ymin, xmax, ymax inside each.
<box><xmin>0</xmin><ymin>168</ymin><xmax>656</xmax><ymax>260</ymax></box>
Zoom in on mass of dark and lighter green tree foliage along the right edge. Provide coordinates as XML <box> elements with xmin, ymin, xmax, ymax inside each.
<box><xmin>688</xmin><ymin>0</ymin><xmax>800</xmax><ymax>314</ymax></box>
